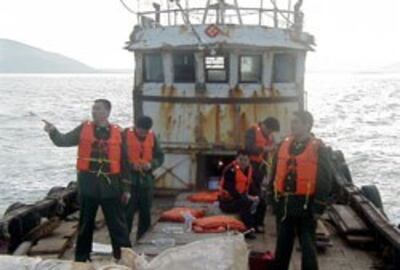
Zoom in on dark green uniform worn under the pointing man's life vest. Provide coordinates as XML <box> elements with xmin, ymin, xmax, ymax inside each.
<box><xmin>50</xmin><ymin>124</ymin><xmax>131</xmax><ymax>261</ymax></box>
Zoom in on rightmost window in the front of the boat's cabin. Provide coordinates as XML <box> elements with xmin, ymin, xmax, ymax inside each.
<box><xmin>273</xmin><ymin>53</ymin><xmax>296</xmax><ymax>83</ymax></box>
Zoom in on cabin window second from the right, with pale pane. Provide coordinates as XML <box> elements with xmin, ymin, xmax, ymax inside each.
<box><xmin>240</xmin><ymin>55</ymin><xmax>262</xmax><ymax>83</ymax></box>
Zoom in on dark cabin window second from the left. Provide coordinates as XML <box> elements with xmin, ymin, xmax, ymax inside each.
<box><xmin>174</xmin><ymin>53</ymin><xmax>195</xmax><ymax>82</ymax></box>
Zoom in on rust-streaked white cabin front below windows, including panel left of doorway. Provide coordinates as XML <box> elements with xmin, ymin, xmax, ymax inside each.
<box><xmin>134</xmin><ymin>83</ymin><xmax>300</xmax><ymax>189</ymax></box>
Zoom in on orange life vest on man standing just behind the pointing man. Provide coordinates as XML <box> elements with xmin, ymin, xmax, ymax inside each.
<box><xmin>126</xmin><ymin>128</ymin><xmax>155</xmax><ymax>164</ymax></box>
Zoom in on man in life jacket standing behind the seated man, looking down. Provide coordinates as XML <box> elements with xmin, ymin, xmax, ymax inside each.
<box><xmin>245</xmin><ymin>117</ymin><xmax>280</xmax><ymax>196</ymax></box>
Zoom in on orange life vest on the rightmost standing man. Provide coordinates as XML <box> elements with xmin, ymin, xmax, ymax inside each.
<box><xmin>274</xmin><ymin>137</ymin><xmax>321</xmax><ymax>196</ymax></box>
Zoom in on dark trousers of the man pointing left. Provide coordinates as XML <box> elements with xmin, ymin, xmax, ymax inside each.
<box><xmin>75</xmin><ymin>181</ymin><xmax>131</xmax><ymax>262</ymax></box>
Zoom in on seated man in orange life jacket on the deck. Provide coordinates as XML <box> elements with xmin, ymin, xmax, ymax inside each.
<box><xmin>219</xmin><ymin>150</ymin><xmax>266</xmax><ymax>239</ymax></box>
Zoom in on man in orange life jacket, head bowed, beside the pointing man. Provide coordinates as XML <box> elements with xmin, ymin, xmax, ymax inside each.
<box><xmin>123</xmin><ymin>116</ymin><xmax>164</xmax><ymax>239</ymax></box>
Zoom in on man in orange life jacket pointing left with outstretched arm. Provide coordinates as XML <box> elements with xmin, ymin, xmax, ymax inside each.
<box><xmin>43</xmin><ymin>99</ymin><xmax>131</xmax><ymax>262</ymax></box>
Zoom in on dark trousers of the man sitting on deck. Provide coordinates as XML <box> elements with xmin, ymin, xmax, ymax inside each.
<box><xmin>219</xmin><ymin>196</ymin><xmax>266</xmax><ymax>228</ymax></box>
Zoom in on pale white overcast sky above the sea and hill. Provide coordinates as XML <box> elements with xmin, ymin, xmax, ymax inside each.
<box><xmin>0</xmin><ymin>0</ymin><xmax>400</xmax><ymax>71</ymax></box>
